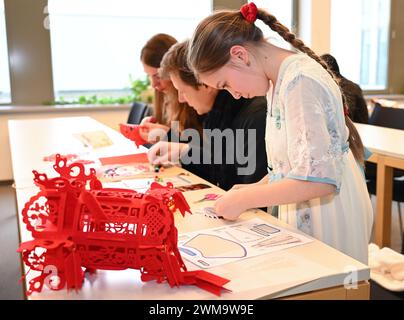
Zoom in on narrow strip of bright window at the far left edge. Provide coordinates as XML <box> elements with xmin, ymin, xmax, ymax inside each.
<box><xmin>0</xmin><ymin>0</ymin><xmax>11</xmax><ymax>103</ymax></box>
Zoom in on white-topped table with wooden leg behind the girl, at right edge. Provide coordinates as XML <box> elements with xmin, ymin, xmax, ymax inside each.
<box><xmin>355</xmin><ymin>119</ymin><xmax>404</xmax><ymax>247</ymax></box>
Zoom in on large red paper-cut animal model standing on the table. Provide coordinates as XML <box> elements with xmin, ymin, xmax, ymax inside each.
<box><xmin>18</xmin><ymin>155</ymin><xmax>229</xmax><ymax>295</ymax></box>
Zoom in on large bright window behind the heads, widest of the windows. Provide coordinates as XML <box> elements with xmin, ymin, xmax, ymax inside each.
<box><xmin>48</xmin><ymin>0</ymin><xmax>212</xmax><ymax>98</ymax></box>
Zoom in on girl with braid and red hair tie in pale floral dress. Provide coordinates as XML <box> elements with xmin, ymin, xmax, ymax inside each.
<box><xmin>188</xmin><ymin>3</ymin><xmax>373</xmax><ymax>263</ymax></box>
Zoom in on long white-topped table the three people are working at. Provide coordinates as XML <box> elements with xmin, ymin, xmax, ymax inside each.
<box><xmin>9</xmin><ymin>117</ymin><xmax>370</xmax><ymax>299</ymax></box>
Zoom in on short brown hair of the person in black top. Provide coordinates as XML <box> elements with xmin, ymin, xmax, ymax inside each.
<box><xmin>159</xmin><ymin>40</ymin><xmax>200</xmax><ymax>89</ymax></box>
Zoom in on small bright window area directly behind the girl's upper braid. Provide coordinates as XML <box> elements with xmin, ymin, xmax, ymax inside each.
<box><xmin>248</xmin><ymin>0</ymin><xmax>296</xmax><ymax>49</ymax></box>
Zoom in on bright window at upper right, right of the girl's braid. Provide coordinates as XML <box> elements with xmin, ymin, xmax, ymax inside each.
<box><xmin>331</xmin><ymin>0</ymin><xmax>391</xmax><ymax>90</ymax></box>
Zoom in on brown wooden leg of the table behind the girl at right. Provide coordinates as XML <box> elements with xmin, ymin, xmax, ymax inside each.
<box><xmin>375</xmin><ymin>157</ymin><xmax>393</xmax><ymax>248</ymax></box>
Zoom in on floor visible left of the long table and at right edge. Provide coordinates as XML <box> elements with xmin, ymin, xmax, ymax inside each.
<box><xmin>0</xmin><ymin>184</ymin><xmax>404</xmax><ymax>300</ymax></box>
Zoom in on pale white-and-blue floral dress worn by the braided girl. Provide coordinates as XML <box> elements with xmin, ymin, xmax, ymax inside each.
<box><xmin>266</xmin><ymin>54</ymin><xmax>373</xmax><ymax>261</ymax></box>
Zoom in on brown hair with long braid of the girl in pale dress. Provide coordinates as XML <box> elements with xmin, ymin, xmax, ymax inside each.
<box><xmin>188</xmin><ymin>9</ymin><xmax>364</xmax><ymax>164</ymax></box>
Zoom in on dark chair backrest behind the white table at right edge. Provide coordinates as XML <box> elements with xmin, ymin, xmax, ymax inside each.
<box><xmin>369</xmin><ymin>103</ymin><xmax>404</xmax><ymax>130</ymax></box>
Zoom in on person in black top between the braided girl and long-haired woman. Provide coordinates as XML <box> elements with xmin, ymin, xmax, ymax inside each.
<box><xmin>149</xmin><ymin>42</ymin><xmax>267</xmax><ymax>190</ymax></box>
